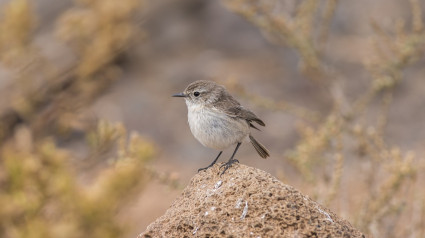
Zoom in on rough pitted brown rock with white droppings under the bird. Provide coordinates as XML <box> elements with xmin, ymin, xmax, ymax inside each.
<box><xmin>139</xmin><ymin>164</ymin><xmax>364</xmax><ymax>238</ymax></box>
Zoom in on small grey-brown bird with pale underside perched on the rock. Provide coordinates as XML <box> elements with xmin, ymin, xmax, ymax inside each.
<box><xmin>173</xmin><ymin>80</ymin><xmax>270</xmax><ymax>174</ymax></box>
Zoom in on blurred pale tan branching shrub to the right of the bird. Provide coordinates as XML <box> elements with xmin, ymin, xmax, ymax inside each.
<box><xmin>223</xmin><ymin>0</ymin><xmax>425</xmax><ymax>237</ymax></box>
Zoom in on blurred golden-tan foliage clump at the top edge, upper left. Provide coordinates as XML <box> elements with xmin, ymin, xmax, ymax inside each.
<box><xmin>58</xmin><ymin>0</ymin><xmax>141</xmax><ymax>78</ymax></box>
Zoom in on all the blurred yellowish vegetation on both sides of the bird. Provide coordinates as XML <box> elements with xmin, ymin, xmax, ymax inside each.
<box><xmin>0</xmin><ymin>0</ymin><xmax>425</xmax><ymax>237</ymax></box>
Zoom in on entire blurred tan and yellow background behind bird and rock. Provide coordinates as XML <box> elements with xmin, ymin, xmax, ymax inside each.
<box><xmin>0</xmin><ymin>0</ymin><xmax>425</xmax><ymax>237</ymax></box>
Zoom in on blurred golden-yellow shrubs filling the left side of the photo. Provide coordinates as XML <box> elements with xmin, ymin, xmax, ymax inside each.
<box><xmin>0</xmin><ymin>0</ymin><xmax>157</xmax><ymax>238</ymax></box>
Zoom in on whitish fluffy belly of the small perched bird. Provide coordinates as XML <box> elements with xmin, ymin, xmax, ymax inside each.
<box><xmin>188</xmin><ymin>109</ymin><xmax>249</xmax><ymax>150</ymax></box>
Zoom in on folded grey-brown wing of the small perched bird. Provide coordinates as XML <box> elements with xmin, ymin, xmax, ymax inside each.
<box><xmin>215</xmin><ymin>92</ymin><xmax>265</xmax><ymax>130</ymax></box>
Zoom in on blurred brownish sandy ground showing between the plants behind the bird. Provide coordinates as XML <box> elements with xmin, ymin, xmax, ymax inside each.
<box><xmin>0</xmin><ymin>0</ymin><xmax>425</xmax><ymax>235</ymax></box>
